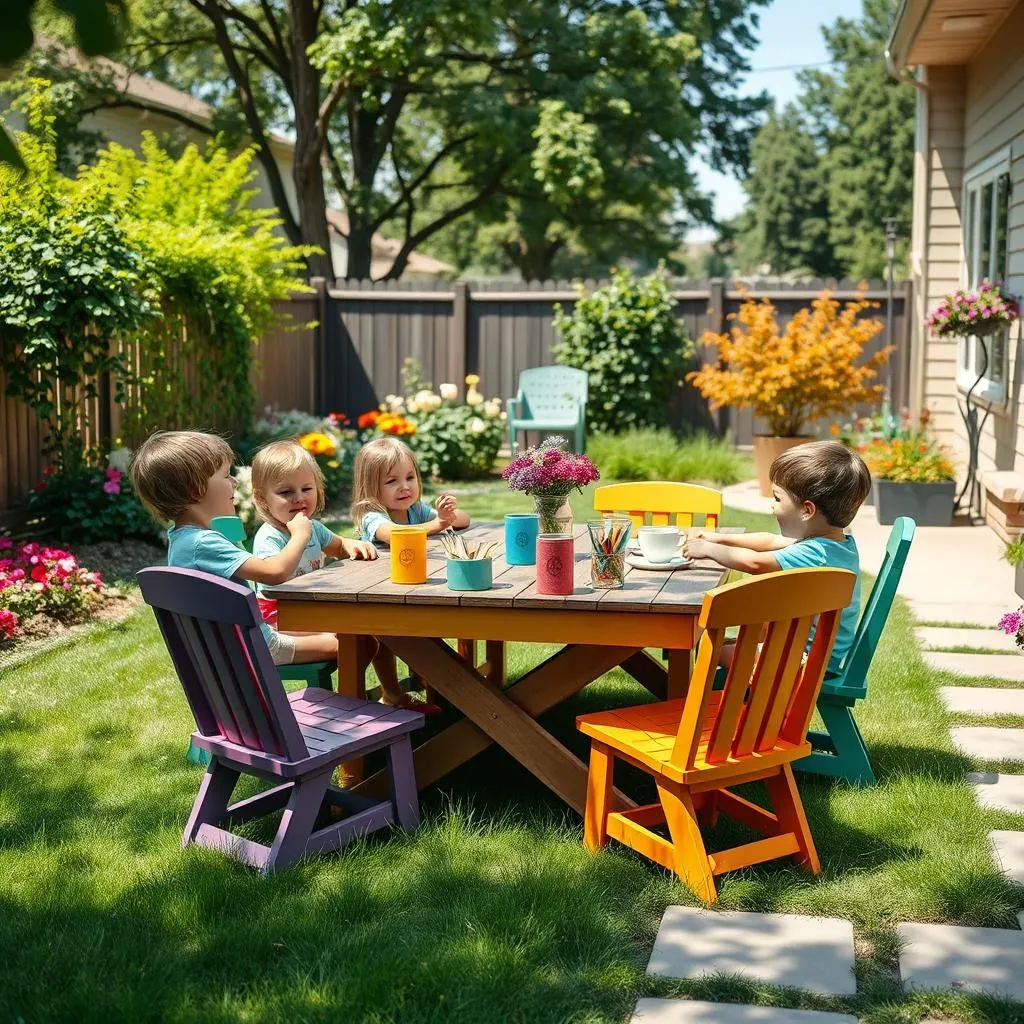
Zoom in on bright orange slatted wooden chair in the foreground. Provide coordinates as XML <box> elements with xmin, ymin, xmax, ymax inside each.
<box><xmin>577</xmin><ymin>569</ymin><xmax>855</xmax><ymax>903</ymax></box>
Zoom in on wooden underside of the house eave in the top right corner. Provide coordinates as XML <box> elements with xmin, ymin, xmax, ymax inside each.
<box><xmin>886</xmin><ymin>0</ymin><xmax>1017</xmax><ymax>73</ymax></box>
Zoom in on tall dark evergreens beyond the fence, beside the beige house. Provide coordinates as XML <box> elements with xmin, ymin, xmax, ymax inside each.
<box><xmin>745</xmin><ymin>0</ymin><xmax>914</xmax><ymax>278</ymax></box>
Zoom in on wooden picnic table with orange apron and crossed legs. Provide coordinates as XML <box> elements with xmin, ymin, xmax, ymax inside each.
<box><xmin>266</xmin><ymin>523</ymin><xmax>727</xmax><ymax>814</ymax></box>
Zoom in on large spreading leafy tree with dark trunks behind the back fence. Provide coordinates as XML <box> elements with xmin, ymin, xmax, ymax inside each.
<box><xmin>14</xmin><ymin>0</ymin><xmax>763</xmax><ymax>276</ymax></box>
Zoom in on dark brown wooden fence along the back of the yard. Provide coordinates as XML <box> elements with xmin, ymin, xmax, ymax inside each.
<box><xmin>313</xmin><ymin>279</ymin><xmax>912</xmax><ymax>444</ymax></box>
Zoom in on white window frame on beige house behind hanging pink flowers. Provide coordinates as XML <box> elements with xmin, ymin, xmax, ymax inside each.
<box><xmin>956</xmin><ymin>146</ymin><xmax>1013</xmax><ymax>406</ymax></box>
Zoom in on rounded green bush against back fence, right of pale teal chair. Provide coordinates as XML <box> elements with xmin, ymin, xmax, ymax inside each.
<box><xmin>554</xmin><ymin>268</ymin><xmax>692</xmax><ymax>432</ymax></box>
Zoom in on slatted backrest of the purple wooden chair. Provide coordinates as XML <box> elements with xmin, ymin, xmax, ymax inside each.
<box><xmin>138</xmin><ymin>567</ymin><xmax>308</xmax><ymax>761</ymax></box>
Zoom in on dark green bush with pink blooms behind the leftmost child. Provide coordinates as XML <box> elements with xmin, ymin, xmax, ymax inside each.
<box><xmin>25</xmin><ymin>466</ymin><xmax>160</xmax><ymax>545</ymax></box>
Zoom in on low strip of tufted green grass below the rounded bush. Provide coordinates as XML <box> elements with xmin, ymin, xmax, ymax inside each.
<box><xmin>587</xmin><ymin>429</ymin><xmax>753</xmax><ymax>486</ymax></box>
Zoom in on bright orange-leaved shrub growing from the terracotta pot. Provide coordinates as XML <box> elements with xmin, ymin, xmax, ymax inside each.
<box><xmin>686</xmin><ymin>290</ymin><xmax>893</xmax><ymax>437</ymax></box>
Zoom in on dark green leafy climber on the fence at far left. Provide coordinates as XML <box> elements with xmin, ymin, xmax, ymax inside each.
<box><xmin>0</xmin><ymin>92</ymin><xmax>157</xmax><ymax>471</ymax></box>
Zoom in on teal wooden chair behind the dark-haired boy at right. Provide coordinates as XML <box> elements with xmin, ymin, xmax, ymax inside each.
<box><xmin>793</xmin><ymin>516</ymin><xmax>916</xmax><ymax>786</ymax></box>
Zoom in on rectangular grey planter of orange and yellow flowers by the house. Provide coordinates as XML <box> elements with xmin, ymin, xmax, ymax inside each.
<box><xmin>861</xmin><ymin>414</ymin><xmax>956</xmax><ymax>526</ymax></box>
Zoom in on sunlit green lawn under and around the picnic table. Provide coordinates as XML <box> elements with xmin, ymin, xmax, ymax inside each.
<box><xmin>0</xmin><ymin>488</ymin><xmax>1024</xmax><ymax>1024</ymax></box>
